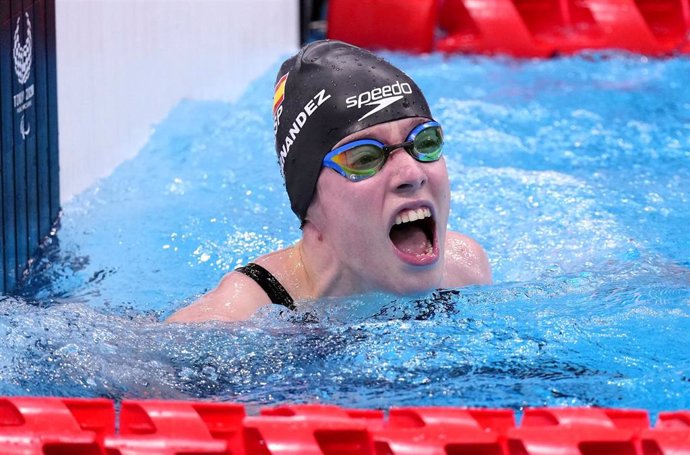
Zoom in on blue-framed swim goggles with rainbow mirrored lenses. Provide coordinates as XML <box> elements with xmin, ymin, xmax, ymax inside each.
<box><xmin>323</xmin><ymin>121</ymin><xmax>443</xmax><ymax>182</ymax></box>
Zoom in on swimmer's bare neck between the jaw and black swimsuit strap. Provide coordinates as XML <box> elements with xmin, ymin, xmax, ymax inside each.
<box><xmin>297</xmin><ymin>223</ymin><xmax>367</xmax><ymax>299</ymax></box>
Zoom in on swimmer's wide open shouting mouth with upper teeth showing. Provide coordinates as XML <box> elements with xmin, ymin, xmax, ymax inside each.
<box><xmin>389</xmin><ymin>207</ymin><xmax>438</xmax><ymax>265</ymax></box>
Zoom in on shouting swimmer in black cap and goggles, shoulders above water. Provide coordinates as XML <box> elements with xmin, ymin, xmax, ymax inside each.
<box><xmin>168</xmin><ymin>40</ymin><xmax>491</xmax><ymax>322</ymax></box>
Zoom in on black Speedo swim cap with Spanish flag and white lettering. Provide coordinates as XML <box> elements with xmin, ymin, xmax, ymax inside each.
<box><xmin>273</xmin><ymin>40</ymin><xmax>431</xmax><ymax>223</ymax></box>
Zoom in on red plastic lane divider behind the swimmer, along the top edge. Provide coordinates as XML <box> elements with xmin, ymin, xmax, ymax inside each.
<box><xmin>328</xmin><ymin>0</ymin><xmax>690</xmax><ymax>57</ymax></box>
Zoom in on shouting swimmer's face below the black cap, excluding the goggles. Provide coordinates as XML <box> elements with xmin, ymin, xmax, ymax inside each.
<box><xmin>307</xmin><ymin>117</ymin><xmax>450</xmax><ymax>294</ymax></box>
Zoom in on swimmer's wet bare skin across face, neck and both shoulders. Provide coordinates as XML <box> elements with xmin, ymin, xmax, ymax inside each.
<box><xmin>169</xmin><ymin>118</ymin><xmax>491</xmax><ymax>322</ymax></box>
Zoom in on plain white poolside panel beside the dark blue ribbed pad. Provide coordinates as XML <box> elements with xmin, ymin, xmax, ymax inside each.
<box><xmin>56</xmin><ymin>0</ymin><xmax>299</xmax><ymax>203</ymax></box>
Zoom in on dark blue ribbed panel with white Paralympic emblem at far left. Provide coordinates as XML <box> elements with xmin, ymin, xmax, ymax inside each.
<box><xmin>0</xmin><ymin>0</ymin><xmax>60</xmax><ymax>292</ymax></box>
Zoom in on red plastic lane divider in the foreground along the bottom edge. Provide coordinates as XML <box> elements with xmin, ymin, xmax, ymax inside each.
<box><xmin>0</xmin><ymin>397</ymin><xmax>690</xmax><ymax>455</ymax></box>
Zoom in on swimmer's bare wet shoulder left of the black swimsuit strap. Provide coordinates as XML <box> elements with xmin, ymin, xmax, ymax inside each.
<box><xmin>166</xmin><ymin>272</ymin><xmax>271</xmax><ymax>322</ymax></box>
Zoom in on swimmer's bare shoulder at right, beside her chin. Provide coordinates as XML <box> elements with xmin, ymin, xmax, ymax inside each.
<box><xmin>443</xmin><ymin>231</ymin><xmax>491</xmax><ymax>287</ymax></box>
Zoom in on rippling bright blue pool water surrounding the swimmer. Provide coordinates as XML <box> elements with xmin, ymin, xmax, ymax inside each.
<box><xmin>0</xmin><ymin>54</ymin><xmax>690</xmax><ymax>413</ymax></box>
